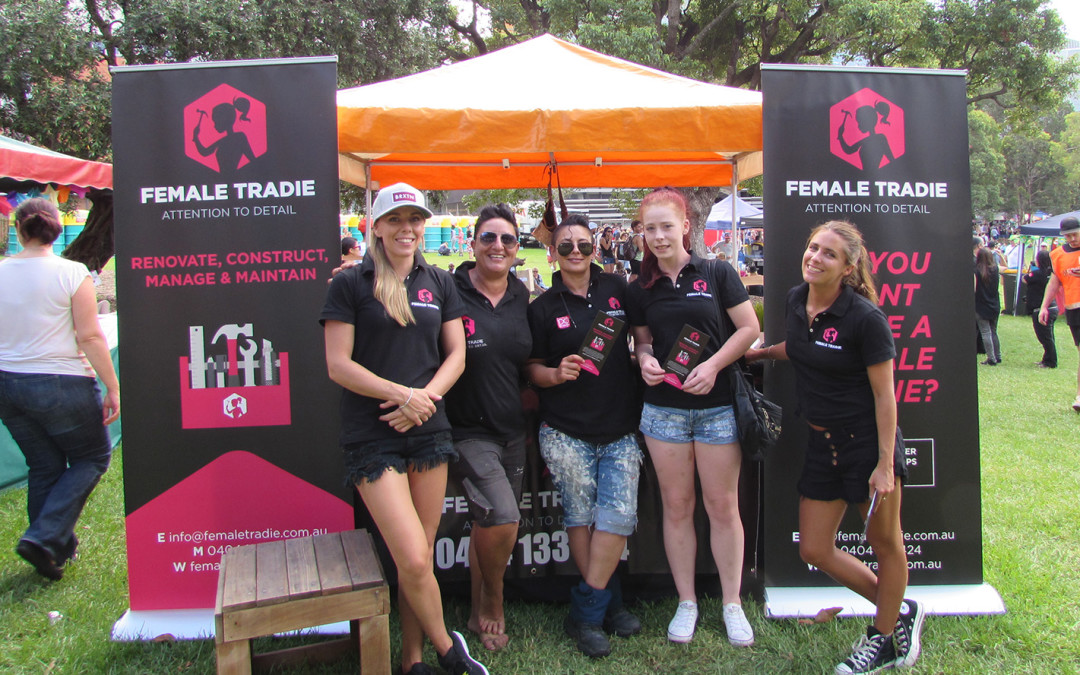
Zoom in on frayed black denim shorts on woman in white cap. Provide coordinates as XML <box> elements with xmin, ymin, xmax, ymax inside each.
<box><xmin>341</xmin><ymin>431</ymin><xmax>458</xmax><ymax>487</ymax></box>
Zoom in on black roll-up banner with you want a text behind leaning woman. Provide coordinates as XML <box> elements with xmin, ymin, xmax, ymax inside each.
<box><xmin>761</xmin><ymin>66</ymin><xmax>1004</xmax><ymax>617</ymax></box>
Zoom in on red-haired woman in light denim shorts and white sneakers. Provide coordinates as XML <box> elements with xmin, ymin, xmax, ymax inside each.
<box><xmin>627</xmin><ymin>188</ymin><xmax>760</xmax><ymax>647</ymax></box>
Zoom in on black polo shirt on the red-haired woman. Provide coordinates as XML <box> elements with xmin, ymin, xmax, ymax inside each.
<box><xmin>626</xmin><ymin>254</ymin><xmax>750</xmax><ymax>409</ymax></box>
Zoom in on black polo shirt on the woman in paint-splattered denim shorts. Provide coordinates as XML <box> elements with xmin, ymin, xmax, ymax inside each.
<box><xmin>529</xmin><ymin>265</ymin><xmax>642</xmax><ymax>443</ymax></box>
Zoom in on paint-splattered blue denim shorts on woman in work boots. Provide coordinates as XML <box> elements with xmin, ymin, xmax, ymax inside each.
<box><xmin>540</xmin><ymin>424</ymin><xmax>644</xmax><ymax>537</ymax></box>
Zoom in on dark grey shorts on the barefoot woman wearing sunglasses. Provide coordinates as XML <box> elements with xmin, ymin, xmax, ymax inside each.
<box><xmin>450</xmin><ymin>435</ymin><xmax>525</xmax><ymax>527</ymax></box>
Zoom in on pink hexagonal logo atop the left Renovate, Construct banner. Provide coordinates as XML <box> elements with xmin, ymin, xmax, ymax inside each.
<box><xmin>184</xmin><ymin>84</ymin><xmax>267</xmax><ymax>176</ymax></box>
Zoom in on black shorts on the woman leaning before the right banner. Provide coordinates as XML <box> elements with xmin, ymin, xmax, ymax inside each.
<box><xmin>798</xmin><ymin>417</ymin><xmax>907</xmax><ymax>504</ymax></box>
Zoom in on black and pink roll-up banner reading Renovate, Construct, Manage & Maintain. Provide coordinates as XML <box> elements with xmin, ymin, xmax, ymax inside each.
<box><xmin>112</xmin><ymin>57</ymin><xmax>353</xmax><ymax>639</ymax></box>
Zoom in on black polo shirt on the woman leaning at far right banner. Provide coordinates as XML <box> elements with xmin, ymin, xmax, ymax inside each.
<box><xmin>786</xmin><ymin>284</ymin><xmax>896</xmax><ymax>427</ymax></box>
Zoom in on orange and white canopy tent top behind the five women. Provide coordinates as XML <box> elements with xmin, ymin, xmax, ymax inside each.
<box><xmin>337</xmin><ymin>35</ymin><xmax>761</xmax><ymax>190</ymax></box>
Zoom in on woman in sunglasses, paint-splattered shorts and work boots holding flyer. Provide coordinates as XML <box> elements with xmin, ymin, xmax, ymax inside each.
<box><xmin>526</xmin><ymin>214</ymin><xmax>642</xmax><ymax>658</ymax></box>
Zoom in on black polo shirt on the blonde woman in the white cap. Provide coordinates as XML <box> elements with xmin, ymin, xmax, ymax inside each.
<box><xmin>319</xmin><ymin>254</ymin><xmax>464</xmax><ymax>445</ymax></box>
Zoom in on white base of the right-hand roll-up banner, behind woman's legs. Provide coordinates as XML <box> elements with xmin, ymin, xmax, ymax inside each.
<box><xmin>765</xmin><ymin>583</ymin><xmax>1005</xmax><ymax>619</ymax></box>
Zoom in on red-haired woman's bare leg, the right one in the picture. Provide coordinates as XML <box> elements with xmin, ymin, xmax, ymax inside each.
<box><xmin>694</xmin><ymin>443</ymin><xmax>744</xmax><ymax>605</ymax></box>
